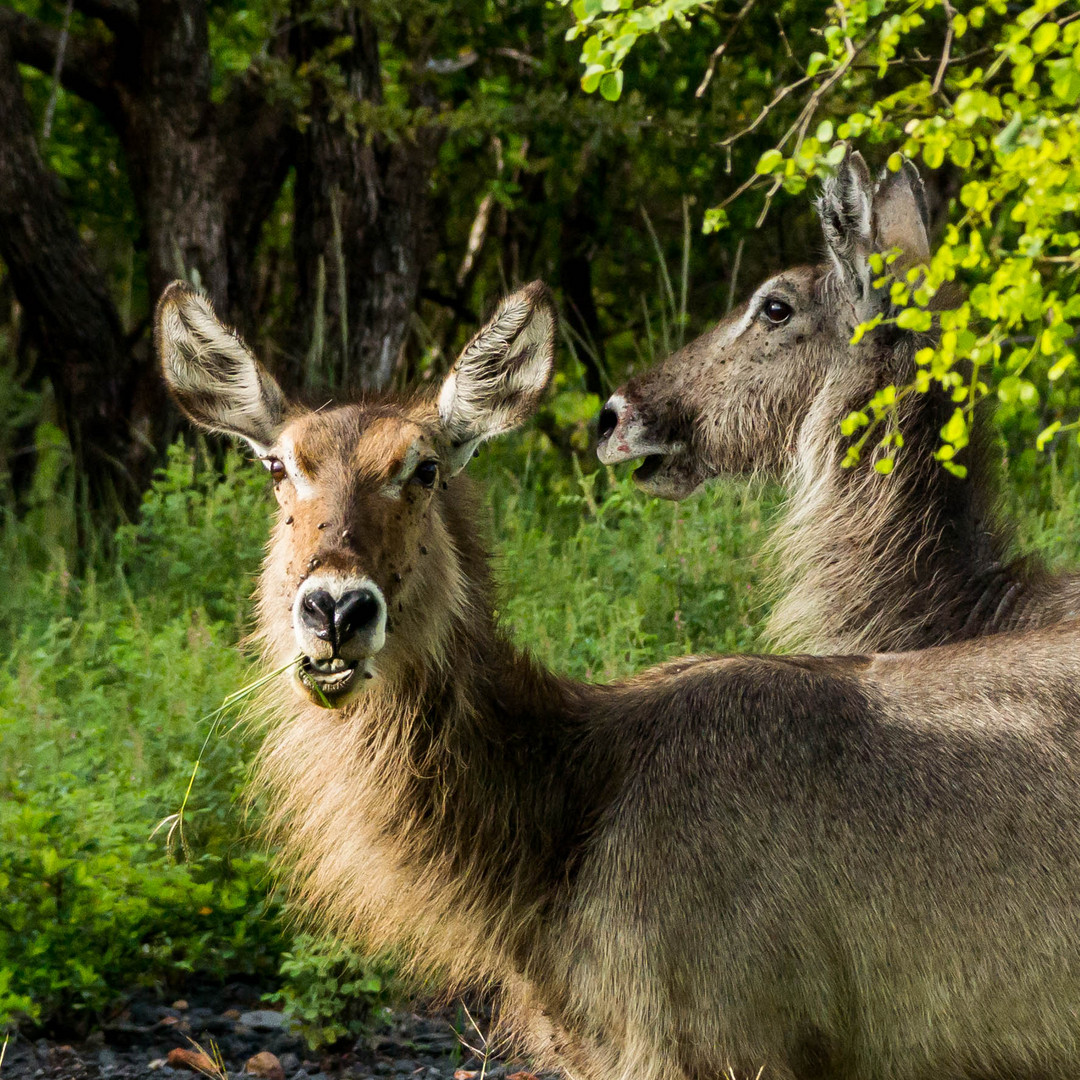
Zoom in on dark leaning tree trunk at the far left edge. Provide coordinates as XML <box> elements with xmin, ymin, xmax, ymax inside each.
<box><xmin>0</xmin><ymin>33</ymin><xmax>147</xmax><ymax>512</ymax></box>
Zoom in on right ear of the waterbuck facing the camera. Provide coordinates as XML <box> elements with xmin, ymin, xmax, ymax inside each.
<box><xmin>438</xmin><ymin>281</ymin><xmax>556</xmax><ymax>472</ymax></box>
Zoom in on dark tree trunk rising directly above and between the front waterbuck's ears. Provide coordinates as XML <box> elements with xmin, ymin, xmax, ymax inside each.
<box><xmin>291</xmin><ymin>3</ymin><xmax>437</xmax><ymax>389</ymax></box>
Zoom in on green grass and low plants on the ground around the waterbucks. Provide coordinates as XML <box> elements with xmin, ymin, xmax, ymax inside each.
<box><xmin>0</xmin><ymin>423</ymin><xmax>1080</xmax><ymax>1027</ymax></box>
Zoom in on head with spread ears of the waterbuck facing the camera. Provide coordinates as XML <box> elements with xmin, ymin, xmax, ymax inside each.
<box><xmin>156</xmin><ymin>282</ymin><xmax>555</xmax><ymax>707</ymax></box>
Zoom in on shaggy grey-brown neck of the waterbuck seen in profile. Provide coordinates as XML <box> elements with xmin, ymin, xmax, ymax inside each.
<box><xmin>769</xmin><ymin>330</ymin><xmax>1041</xmax><ymax>652</ymax></box>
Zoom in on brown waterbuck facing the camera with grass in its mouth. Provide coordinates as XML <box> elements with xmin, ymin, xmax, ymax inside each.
<box><xmin>157</xmin><ymin>285</ymin><xmax>1080</xmax><ymax>1080</ymax></box>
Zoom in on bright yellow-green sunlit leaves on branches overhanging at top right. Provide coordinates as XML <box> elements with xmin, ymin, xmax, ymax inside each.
<box><xmin>573</xmin><ymin>0</ymin><xmax>1080</xmax><ymax>475</ymax></box>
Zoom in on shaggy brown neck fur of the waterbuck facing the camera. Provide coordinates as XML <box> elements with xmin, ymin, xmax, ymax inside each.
<box><xmin>248</xmin><ymin>486</ymin><xmax>613</xmax><ymax>987</ymax></box>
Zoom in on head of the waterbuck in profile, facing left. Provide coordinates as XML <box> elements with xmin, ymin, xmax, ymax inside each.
<box><xmin>597</xmin><ymin>152</ymin><xmax>930</xmax><ymax>499</ymax></box>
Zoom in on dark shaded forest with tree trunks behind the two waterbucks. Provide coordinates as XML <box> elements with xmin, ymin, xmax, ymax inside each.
<box><xmin>0</xmin><ymin>0</ymin><xmax>842</xmax><ymax>531</ymax></box>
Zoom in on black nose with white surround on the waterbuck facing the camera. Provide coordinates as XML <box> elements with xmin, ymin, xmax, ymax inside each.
<box><xmin>294</xmin><ymin>579</ymin><xmax>387</xmax><ymax>658</ymax></box>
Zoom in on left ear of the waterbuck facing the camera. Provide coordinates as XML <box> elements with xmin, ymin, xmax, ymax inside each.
<box><xmin>153</xmin><ymin>281</ymin><xmax>285</xmax><ymax>455</ymax></box>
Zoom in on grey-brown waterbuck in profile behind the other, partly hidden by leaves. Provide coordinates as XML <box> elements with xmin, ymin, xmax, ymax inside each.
<box><xmin>598</xmin><ymin>153</ymin><xmax>1080</xmax><ymax>652</ymax></box>
